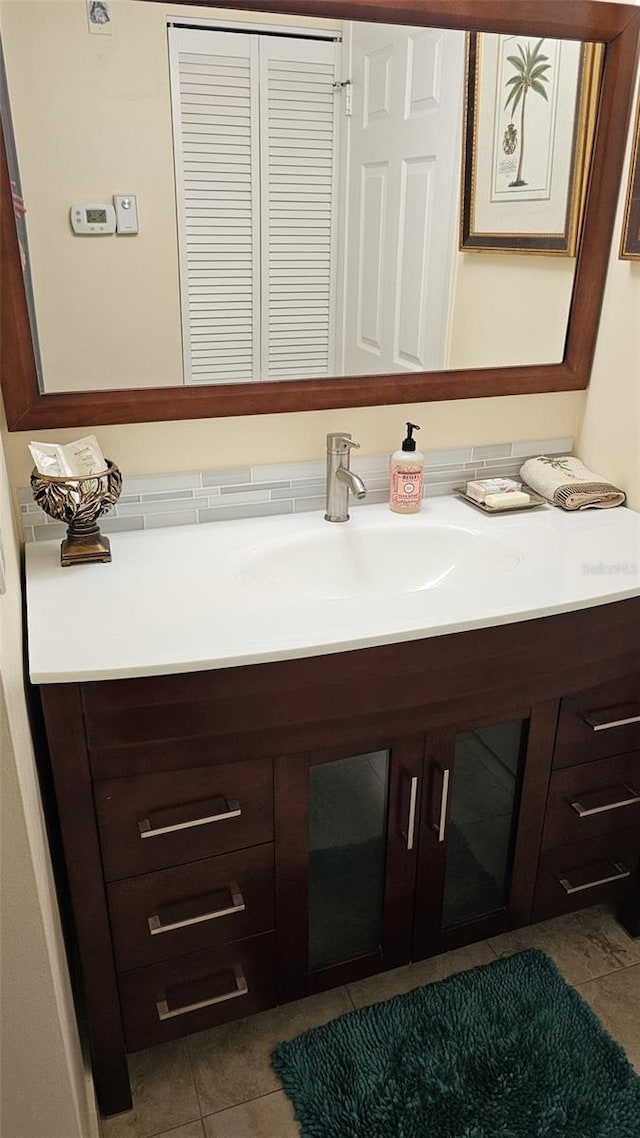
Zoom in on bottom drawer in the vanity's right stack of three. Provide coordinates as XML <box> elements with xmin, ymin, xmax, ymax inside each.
<box><xmin>532</xmin><ymin>827</ymin><xmax>640</xmax><ymax>921</ymax></box>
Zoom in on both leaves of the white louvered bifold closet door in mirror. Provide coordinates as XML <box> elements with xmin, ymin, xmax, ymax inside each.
<box><xmin>170</xmin><ymin>28</ymin><xmax>339</xmax><ymax>384</ymax></box>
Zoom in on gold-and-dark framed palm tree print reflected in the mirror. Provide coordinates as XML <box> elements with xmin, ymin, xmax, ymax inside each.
<box><xmin>460</xmin><ymin>32</ymin><xmax>601</xmax><ymax>257</ymax></box>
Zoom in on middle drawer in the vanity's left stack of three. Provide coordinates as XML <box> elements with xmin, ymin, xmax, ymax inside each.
<box><xmin>107</xmin><ymin>843</ymin><xmax>274</xmax><ymax>972</ymax></box>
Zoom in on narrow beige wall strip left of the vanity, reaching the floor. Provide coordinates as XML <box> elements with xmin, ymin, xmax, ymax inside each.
<box><xmin>0</xmin><ymin>414</ymin><xmax>97</xmax><ymax>1138</ymax></box>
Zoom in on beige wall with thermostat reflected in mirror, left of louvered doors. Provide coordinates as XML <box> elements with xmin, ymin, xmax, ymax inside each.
<box><xmin>0</xmin><ymin>0</ymin><xmax>181</xmax><ymax>391</ymax></box>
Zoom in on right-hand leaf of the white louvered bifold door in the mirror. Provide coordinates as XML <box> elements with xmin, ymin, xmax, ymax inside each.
<box><xmin>260</xmin><ymin>36</ymin><xmax>340</xmax><ymax>379</ymax></box>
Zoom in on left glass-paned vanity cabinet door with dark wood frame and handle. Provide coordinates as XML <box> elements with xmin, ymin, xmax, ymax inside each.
<box><xmin>276</xmin><ymin>735</ymin><xmax>424</xmax><ymax>1000</ymax></box>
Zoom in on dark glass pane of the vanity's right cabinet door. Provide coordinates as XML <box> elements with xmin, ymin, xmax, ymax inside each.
<box><xmin>442</xmin><ymin>719</ymin><xmax>527</xmax><ymax>929</ymax></box>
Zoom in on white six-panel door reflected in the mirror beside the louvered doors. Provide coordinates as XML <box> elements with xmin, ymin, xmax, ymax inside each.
<box><xmin>342</xmin><ymin>24</ymin><xmax>465</xmax><ymax>376</ymax></box>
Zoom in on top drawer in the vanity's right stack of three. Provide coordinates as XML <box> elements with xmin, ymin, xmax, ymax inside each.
<box><xmin>553</xmin><ymin>674</ymin><xmax>640</xmax><ymax>767</ymax></box>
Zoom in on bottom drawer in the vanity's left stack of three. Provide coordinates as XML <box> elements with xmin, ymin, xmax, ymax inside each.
<box><xmin>118</xmin><ymin>933</ymin><xmax>276</xmax><ymax>1052</ymax></box>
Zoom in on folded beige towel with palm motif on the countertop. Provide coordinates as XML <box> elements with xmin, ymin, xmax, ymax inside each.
<box><xmin>520</xmin><ymin>455</ymin><xmax>625</xmax><ymax>510</ymax></box>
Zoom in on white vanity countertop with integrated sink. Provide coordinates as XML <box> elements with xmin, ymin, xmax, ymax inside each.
<box><xmin>26</xmin><ymin>497</ymin><xmax>640</xmax><ymax>684</ymax></box>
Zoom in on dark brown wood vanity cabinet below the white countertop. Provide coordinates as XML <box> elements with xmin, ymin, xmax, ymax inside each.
<box><xmin>40</xmin><ymin>599</ymin><xmax>640</xmax><ymax>1114</ymax></box>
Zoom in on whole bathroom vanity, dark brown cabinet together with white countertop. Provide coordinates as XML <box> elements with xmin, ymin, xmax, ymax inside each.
<box><xmin>27</xmin><ymin>498</ymin><xmax>640</xmax><ymax>1114</ymax></box>
